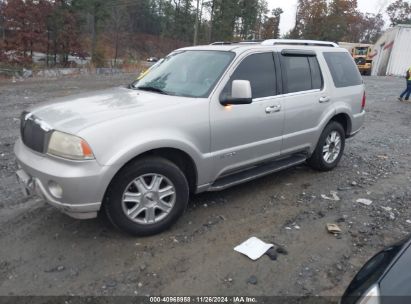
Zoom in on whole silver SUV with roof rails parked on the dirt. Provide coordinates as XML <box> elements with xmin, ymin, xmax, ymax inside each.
<box><xmin>15</xmin><ymin>40</ymin><xmax>365</xmax><ymax>235</ymax></box>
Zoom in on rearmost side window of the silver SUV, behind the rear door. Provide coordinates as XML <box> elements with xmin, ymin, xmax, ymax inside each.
<box><xmin>324</xmin><ymin>52</ymin><xmax>362</xmax><ymax>88</ymax></box>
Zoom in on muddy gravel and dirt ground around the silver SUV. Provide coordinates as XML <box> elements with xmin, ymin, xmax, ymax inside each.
<box><xmin>0</xmin><ymin>75</ymin><xmax>411</xmax><ymax>296</ymax></box>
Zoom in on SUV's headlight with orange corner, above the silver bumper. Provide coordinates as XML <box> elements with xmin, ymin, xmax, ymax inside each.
<box><xmin>47</xmin><ymin>131</ymin><xmax>94</xmax><ymax>160</ymax></box>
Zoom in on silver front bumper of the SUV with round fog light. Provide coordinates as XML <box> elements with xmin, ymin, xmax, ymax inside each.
<box><xmin>14</xmin><ymin>139</ymin><xmax>114</xmax><ymax>219</ymax></box>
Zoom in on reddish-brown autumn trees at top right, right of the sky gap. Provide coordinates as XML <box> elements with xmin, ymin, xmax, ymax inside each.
<box><xmin>286</xmin><ymin>0</ymin><xmax>411</xmax><ymax>43</ymax></box>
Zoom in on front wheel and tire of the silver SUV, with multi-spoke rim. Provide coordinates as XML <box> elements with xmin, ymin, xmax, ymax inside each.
<box><xmin>104</xmin><ymin>157</ymin><xmax>189</xmax><ymax>236</ymax></box>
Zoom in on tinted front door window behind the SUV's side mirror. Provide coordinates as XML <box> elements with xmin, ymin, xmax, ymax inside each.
<box><xmin>222</xmin><ymin>53</ymin><xmax>277</xmax><ymax>98</ymax></box>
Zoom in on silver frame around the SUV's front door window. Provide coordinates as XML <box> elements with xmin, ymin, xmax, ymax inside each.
<box><xmin>218</xmin><ymin>50</ymin><xmax>282</xmax><ymax>103</ymax></box>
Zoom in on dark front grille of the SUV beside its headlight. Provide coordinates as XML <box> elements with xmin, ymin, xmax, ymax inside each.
<box><xmin>20</xmin><ymin>112</ymin><xmax>51</xmax><ymax>153</ymax></box>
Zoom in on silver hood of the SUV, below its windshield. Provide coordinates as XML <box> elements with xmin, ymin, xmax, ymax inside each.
<box><xmin>29</xmin><ymin>87</ymin><xmax>185</xmax><ymax>133</ymax></box>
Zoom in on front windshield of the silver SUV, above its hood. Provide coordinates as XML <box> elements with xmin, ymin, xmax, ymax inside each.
<box><xmin>131</xmin><ymin>51</ymin><xmax>235</xmax><ymax>97</ymax></box>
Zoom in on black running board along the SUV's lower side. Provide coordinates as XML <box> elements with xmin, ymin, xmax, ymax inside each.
<box><xmin>208</xmin><ymin>154</ymin><xmax>307</xmax><ymax>191</ymax></box>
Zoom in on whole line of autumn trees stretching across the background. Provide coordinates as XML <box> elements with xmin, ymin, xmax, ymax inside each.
<box><xmin>0</xmin><ymin>0</ymin><xmax>411</xmax><ymax>66</ymax></box>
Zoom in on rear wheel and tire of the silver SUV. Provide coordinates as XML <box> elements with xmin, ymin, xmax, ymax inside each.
<box><xmin>307</xmin><ymin>121</ymin><xmax>345</xmax><ymax>171</ymax></box>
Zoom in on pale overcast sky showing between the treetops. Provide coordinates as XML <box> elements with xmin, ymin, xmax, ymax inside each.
<box><xmin>267</xmin><ymin>0</ymin><xmax>394</xmax><ymax>34</ymax></box>
